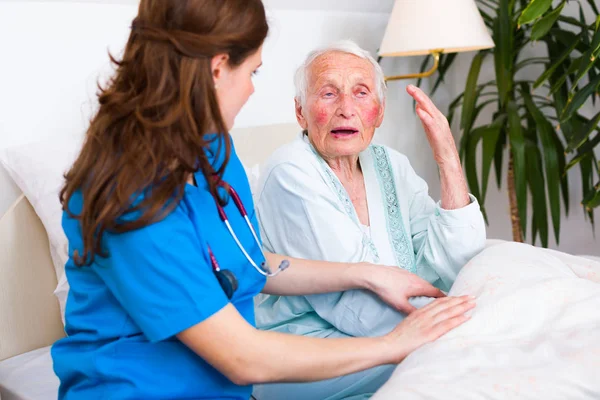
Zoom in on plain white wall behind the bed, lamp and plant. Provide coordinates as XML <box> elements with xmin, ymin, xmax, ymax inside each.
<box><xmin>0</xmin><ymin>0</ymin><xmax>600</xmax><ymax>255</ymax></box>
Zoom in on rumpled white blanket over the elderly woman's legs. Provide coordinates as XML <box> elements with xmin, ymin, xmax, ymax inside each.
<box><xmin>372</xmin><ymin>243</ymin><xmax>600</xmax><ymax>400</ymax></box>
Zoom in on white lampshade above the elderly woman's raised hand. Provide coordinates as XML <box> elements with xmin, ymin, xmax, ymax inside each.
<box><xmin>379</xmin><ymin>0</ymin><xmax>494</xmax><ymax>57</ymax></box>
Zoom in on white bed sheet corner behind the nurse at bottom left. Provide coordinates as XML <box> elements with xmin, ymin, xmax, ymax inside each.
<box><xmin>0</xmin><ymin>347</ymin><xmax>59</xmax><ymax>400</ymax></box>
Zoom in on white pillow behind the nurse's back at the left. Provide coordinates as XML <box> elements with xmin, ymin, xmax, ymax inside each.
<box><xmin>0</xmin><ymin>137</ymin><xmax>82</xmax><ymax>322</ymax></box>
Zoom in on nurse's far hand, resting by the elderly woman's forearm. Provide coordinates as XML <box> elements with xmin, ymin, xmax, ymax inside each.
<box><xmin>369</xmin><ymin>265</ymin><xmax>446</xmax><ymax>314</ymax></box>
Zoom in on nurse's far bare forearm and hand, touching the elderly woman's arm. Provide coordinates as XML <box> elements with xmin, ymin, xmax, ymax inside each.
<box><xmin>262</xmin><ymin>252</ymin><xmax>445</xmax><ymax>313</ymax></box>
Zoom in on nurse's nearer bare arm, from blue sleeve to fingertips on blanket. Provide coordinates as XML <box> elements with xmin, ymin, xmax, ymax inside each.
<box><xmin>177</xmin><ymin>297</ymin><xmax>474</xmax><ymax>385</ymax></box>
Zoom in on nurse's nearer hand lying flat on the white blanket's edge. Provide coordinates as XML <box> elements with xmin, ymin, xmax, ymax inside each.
<box><xmin>384</xmin><ymin>296</ymin><xmax>475</xmax><ymax>364</ymax></box>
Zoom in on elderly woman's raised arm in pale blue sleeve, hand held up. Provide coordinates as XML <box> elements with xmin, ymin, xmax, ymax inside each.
<box><xmin>406</xmin><ymin>85</ymin><xmax>485</xmax><ymax>290</ymax></box>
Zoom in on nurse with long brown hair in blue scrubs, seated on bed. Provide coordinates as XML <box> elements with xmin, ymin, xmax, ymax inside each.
<box><xmin>52</xmin><ymin>0</ymin><xmax>474</xmax><ymax>399</ymax></box>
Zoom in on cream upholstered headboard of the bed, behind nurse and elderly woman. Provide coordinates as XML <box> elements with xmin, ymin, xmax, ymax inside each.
<box><xmin>0</xmin><ymin>124</ymin><xmax>300</xmax><ymax>361</ymax></box>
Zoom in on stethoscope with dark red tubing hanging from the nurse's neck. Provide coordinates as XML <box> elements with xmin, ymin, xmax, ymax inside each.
<box><xmin>207</xmin><ymin>180</ymin><xmax>290</xmax><ymax>299</ymax></box>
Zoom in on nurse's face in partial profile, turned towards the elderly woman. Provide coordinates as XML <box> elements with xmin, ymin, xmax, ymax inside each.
<box><xmin>213</xmin><ymin>46</ymin><xmax>262</xmax><ymax>130</ymax></box>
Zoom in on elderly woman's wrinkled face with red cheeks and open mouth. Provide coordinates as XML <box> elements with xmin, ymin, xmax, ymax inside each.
<box><xmin>296</xmin><ymin>52</ymin><xmax>384</xmax><ymax>158</ymax></box>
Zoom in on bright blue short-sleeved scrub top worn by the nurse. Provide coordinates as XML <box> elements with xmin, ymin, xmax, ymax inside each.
<box><xmin>52</xmin><ymin>138</ymin><xmax>265</xmax><ymax>400</ymax></box>
